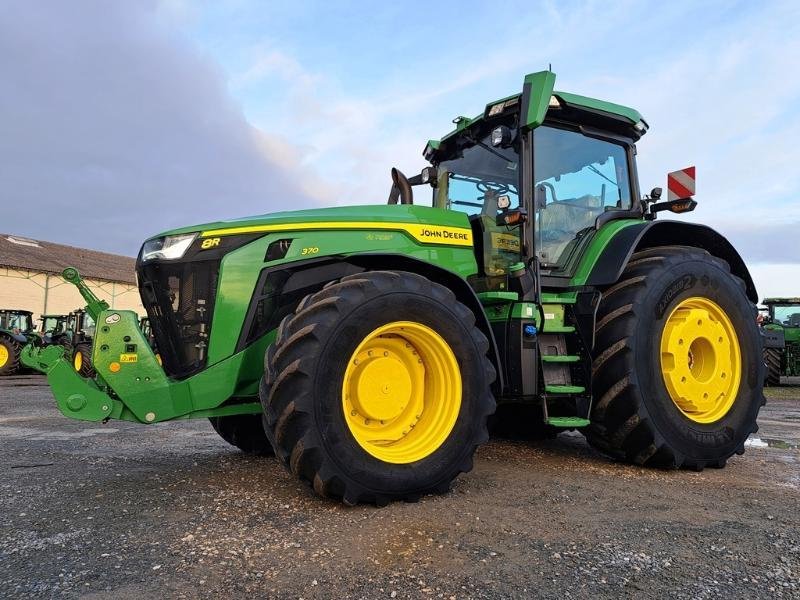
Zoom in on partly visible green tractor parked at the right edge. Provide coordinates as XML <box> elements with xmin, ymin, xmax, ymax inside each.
<box><xmin>763</xmin><ymin>298</ymin><xmax>800</xmax><ymax>386</ymax></box>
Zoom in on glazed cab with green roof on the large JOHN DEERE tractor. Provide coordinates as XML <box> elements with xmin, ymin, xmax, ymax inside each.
<box><xmin>389</xmin><ymin>73</ymin><xmax>647</xmax><ymax>292</ymax></box>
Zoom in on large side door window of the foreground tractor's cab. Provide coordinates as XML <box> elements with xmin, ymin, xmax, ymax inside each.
<box><xmin>533</xmin><ymin>127</ymin><xmax>631</xmax><ymax>269</ymax></box>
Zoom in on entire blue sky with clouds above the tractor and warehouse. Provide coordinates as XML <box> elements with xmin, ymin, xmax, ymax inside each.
<box><xmin>0</xmin><ymin>0</ymin><xmax>800</xmax><ymax>295</ymax></box>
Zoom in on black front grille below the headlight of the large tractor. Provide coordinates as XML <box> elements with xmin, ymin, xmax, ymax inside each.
<box><xmin>139</xmin><ymin>259</ymin><xmax>220</xmax><ymax>378</ymax></box>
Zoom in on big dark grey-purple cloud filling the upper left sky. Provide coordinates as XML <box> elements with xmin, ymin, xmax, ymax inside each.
<box><xmin>0</xmin><ymin>2</ymin><xmax>324</xmax><ymax>254</ymax></box>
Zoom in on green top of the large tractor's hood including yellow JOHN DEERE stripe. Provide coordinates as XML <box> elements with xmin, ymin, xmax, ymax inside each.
<box><xmin>145</xmin><ymin>204</ymin><xmax>471</xmax><ymax>245</ymax></box>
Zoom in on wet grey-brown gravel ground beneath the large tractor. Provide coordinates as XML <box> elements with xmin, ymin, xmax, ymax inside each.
<box><xmin>0</xmin><ymin>376</ymin><xmax>800</xmax><ymax>600</ymax></box>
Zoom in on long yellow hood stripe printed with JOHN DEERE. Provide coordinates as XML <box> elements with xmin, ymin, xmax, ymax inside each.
<box><xmin>200</xmin><ymin>221</ymin><xmax>472</xmax><ymax>246</ymax></box>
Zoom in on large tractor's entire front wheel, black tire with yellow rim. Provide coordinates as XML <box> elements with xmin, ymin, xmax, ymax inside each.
<box><xmin>261</xmin><ymin>271</ymin><xmax>495</xmax><ymax>506</ymax></box>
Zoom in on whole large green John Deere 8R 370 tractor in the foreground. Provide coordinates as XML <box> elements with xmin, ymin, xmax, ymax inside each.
<box><xmin>25</xmin><ymin>72</ymin><xmax>764</xmax><ymax>505</ymax></box>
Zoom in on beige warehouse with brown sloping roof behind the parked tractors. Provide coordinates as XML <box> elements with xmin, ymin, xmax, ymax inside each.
<box><xmin>0</xmin><ymin>234</ymin><xmax>145</xmax><ymax>319</ymax></box>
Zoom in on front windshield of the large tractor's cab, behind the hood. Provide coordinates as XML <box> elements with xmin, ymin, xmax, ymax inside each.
<box><xmin>433</xmin><ymin>135</ymin><xmax>521</xmax><ymax>282</ymax></box>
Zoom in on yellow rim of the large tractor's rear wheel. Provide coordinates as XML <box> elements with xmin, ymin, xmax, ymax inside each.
<box><xmin>661</xmin><ymin>297</ymin><xmax>742</xmax><ymax>423</ymax></box>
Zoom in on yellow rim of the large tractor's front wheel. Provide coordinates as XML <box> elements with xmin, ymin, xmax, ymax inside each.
<box><xmin>342</xmin><ymin>321</ymin><xmax>461</xmax><ymax>464</ymax></box>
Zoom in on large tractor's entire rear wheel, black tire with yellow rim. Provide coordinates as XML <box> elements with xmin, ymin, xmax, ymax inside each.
<box><xmin>587</xmin><ymin>246</ymin><xmax>764</xmax><ymax>470</ymax></box>
